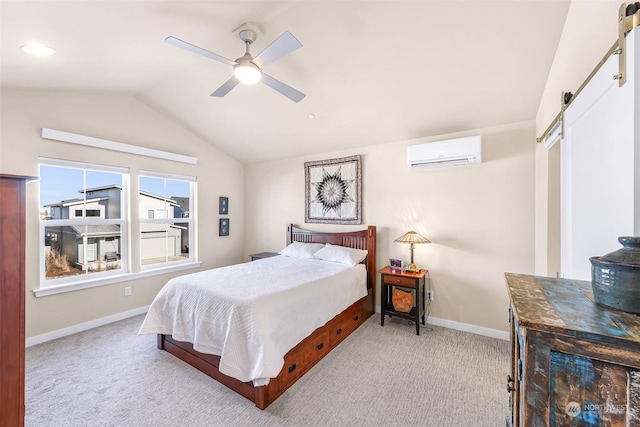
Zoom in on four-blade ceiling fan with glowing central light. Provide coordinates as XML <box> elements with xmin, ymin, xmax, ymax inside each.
<box><xmin>165</xmin><ymin>27</ymin><xmax>306</xmax><ymax>102</ymax></box>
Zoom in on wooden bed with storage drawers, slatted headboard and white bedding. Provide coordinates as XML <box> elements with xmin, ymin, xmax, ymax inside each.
<box><xmin>140</xmin><ymin>224</ymin><xmax>376</xmax><ymax>409</ymax></box>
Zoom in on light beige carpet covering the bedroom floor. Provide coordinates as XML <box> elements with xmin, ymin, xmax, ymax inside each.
<box><xmin>25</xmin><ymin>314</ymin><xmax>509</xmax><ymax>427</ymax></box>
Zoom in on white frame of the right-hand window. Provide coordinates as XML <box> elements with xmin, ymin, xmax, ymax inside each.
<box><xmin>138</xmin><ymin>170</ymin><xmax>198</xmax><ymax>271</ymax></box>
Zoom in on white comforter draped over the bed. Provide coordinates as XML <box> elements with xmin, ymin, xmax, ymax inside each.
<box><xmin>139</xmin><ymin>256</ymin><xmax>367</xmax><ymax>386</ymax></box>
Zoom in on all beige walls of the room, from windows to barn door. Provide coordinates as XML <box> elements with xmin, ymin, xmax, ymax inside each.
<box><xmin>5</xmin><ymin>0</ymin><xmax>620</xmax><ymax>337</ymax></box>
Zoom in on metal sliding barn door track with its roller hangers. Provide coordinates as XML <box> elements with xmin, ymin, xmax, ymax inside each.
<box><xmin>536</xmin><ymin>2</ymin><xmax>640</xmax><ymax>143</ymax></box>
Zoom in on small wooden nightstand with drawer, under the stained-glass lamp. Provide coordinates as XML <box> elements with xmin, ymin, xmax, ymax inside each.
<box><xmin>378</xmin><ymin>266</ymin><xmax>429</xmax><ymax>335</ymax></box>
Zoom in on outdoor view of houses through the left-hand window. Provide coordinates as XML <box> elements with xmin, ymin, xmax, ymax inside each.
<box><xmin>40</xmin><ymin>160</ymin><xmax>128</xmax><ymax>286</ymax></box>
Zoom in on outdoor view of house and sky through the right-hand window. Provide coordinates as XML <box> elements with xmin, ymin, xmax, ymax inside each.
<box><xmin>138</xmin><ymin>172</ymin><xmax>195</xmax><ymax>269</ymax></box>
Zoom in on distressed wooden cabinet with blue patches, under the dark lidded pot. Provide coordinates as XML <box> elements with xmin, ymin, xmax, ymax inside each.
<box><xmin>505</xmin><ymin>273</ymin><xmax>640</xmax><ymax>427</ymax></box>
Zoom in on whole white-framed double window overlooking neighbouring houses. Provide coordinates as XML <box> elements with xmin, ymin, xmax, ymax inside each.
<box><xmin>34</xmin><ymin>158</ymin><xmax>200</xmax><ymax>296</ymax></box>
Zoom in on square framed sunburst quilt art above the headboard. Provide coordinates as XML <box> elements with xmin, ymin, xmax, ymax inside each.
<box><xmin>304</xmin><ymin>156</ymin><xmax>362</xmax><ymax>224</ymax></box>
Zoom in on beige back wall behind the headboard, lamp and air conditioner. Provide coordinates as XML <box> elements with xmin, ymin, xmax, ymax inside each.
<box><xmin>245</xmin><ymin>121</ymin><xmax>535</xmax><ymax>331</ymax></box>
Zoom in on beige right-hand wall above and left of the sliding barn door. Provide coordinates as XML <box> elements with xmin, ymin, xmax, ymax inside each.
<box><xmin>535</xmin><ymin>0</ymin><xmax>622</xmax><ymax>275</ymax></box>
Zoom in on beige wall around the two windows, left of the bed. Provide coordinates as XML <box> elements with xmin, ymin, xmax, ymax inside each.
<box><xmin>0</xmin><ymin>90</ymin><xmax>247</xmax><ymax>337</ymax></box>
